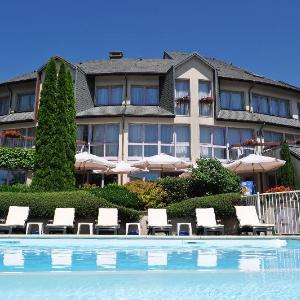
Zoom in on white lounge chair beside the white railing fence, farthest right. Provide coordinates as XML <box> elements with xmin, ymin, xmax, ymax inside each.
<box><xmin>235</xmin><ymin>205</ymin><xmax>275</xmax><ymax>235</ymax></box>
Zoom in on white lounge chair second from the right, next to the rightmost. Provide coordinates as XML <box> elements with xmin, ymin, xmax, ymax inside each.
<box><xmin>196</xmin><ymin>208</ymin><xmax>224</xmax><ymax>234</ymax></box>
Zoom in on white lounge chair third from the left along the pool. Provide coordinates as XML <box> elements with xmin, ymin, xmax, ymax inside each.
<box><xmin>95</xmin><ymin>208</ymin><xmax>120</xmax><ymax>234</ymax></box>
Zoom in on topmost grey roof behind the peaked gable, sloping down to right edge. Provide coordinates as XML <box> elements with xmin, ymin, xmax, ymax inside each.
<box><xmin>166</xmin><ymin>52</ymin><xmax>300</xmax><ymax>92</ymax></box>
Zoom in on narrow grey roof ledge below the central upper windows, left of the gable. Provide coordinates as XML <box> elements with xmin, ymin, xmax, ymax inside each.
<box><xmin>77</xmin><ymin>106</ymin><xmax>174</xmax><ymax>117</ymax></box>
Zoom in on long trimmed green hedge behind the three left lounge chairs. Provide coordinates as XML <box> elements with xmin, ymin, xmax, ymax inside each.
<box><xmin>0</xmin><ymin>191</ymin><xmax>139</xmax><ymax>222</ymax></box>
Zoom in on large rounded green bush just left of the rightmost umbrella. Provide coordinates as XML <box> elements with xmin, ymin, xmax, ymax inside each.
<box><xmin>186</xmin><ymin>159</ymin><xmax>241</xmax><ymax>197</ymax></box>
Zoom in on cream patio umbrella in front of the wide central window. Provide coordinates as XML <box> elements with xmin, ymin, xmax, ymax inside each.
<box><xmin>132</xmin><ymin>153</ymin><xmax>189</xmax><ymax>171</ymax></box>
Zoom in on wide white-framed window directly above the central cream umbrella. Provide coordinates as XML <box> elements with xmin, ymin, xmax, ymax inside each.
<box><xmin>128</xmin><ymin>124</ymin><xmax>190</xmax><ymax>159</ymax></box>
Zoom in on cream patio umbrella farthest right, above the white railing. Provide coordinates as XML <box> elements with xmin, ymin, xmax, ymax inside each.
<box><xmin>225</xmin><ymin>154</ymin><xmax>285</xmax><ymax>174</ymax></box>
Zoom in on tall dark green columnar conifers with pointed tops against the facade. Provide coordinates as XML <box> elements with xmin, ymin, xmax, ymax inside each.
<box><xmin>32</xmin><ymin>58</ymin><xmax>75</xmax><ymax>191</ymax></box>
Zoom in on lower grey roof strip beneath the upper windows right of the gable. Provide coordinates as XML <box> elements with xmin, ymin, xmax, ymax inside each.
<box><xmin>217</xmin><ymin>110</ymin><xmax>300</xmax><ymax>128</ymax></box>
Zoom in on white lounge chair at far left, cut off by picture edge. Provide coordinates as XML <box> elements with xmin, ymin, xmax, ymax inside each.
<box><xmin>0</xmin><ymin>206</ymin><xmax>29</xmax><ymax>234</ymax></box>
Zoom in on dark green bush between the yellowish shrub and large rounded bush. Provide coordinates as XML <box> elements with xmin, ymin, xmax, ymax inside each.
<box><xmin>157</xmin><ymin>177</ymin><xmax>191</xmax><ymax>204</ymax></box>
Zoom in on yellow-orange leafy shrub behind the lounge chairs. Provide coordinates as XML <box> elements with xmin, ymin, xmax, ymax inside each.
<box><xmin>125</xmin><ymin>180</ymin><xmax>167</xmax><ymax>208</ymax></box>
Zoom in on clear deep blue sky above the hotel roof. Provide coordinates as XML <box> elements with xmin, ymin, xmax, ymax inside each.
<box><xmin>0</xmin><ymin>0</ymin><xmax>300</xmax><ymax>86</ymax></box>
